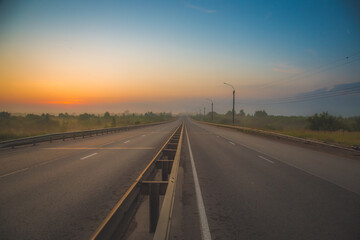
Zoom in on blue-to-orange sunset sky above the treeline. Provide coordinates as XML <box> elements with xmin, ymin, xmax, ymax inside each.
<box><xmin>0</xmin><ymin>0</ymin><xmax>360</xmax><ymax>116</ymax></box>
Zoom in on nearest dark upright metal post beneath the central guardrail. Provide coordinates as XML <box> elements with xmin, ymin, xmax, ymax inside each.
<box><xmin>149</xmin><ymin>183</ymin><xmax>160</xmax><ymax>233</ymax></box>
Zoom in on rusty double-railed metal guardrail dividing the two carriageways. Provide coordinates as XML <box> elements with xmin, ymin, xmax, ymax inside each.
<box><xmin>91</xmin><ymin>123</ymin><xmax>184</xmax><ymax>240</ymax></box>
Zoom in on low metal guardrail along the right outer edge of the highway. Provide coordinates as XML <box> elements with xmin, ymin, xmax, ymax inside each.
<box><xmin>194</xmin><ymin>120</ymin><xmax>359</xmax><ymax>153</ymax></box>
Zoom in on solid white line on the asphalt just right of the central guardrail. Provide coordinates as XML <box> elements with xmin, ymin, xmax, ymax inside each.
<box><xmin>185</xmin><ymin>127</ymin><xmax>211</xmax><ymax>240</ymax></box>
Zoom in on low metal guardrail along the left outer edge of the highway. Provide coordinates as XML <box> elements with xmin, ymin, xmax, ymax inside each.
<box><xmin>0</xmin><ymin>121</ymin><xmax>168</xmax><ymax>148</ymax></box>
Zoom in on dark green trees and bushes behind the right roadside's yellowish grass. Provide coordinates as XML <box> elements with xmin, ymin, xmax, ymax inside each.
<box><xmin>194</xmin><ymin>110</ymin><xmax>360</xmax><ymax>132</ymax></box>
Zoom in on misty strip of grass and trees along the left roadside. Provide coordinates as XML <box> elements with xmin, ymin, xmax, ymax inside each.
<box><xmin>0</xmin><ymin>112</ymin><xmax>173</xmax><ymax>141</ymax></box>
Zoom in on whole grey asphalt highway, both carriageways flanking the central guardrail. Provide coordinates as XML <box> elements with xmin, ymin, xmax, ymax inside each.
<box><xmin>0</xmin><ymin>119</ymin><xmax>360</xmax><ymax>239</ymax></box>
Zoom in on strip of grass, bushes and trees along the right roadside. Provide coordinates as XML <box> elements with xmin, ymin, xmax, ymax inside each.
<box><xmin>193</xmin><ymin>110</ymin><xmax>360</xmax><ymax>146</ymax></box>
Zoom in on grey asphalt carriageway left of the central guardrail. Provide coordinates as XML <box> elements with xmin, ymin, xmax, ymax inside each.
<box><xmin>0</xmin><ymin>120</ymin><xmax>180</xmax><ymax>239</ymax></box>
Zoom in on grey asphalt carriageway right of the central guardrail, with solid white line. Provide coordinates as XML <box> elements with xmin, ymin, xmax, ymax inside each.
<box><xmin>172</xmin><ymin>119</ymin><xmax>360</xmax><ymax>239</ymax></box>
